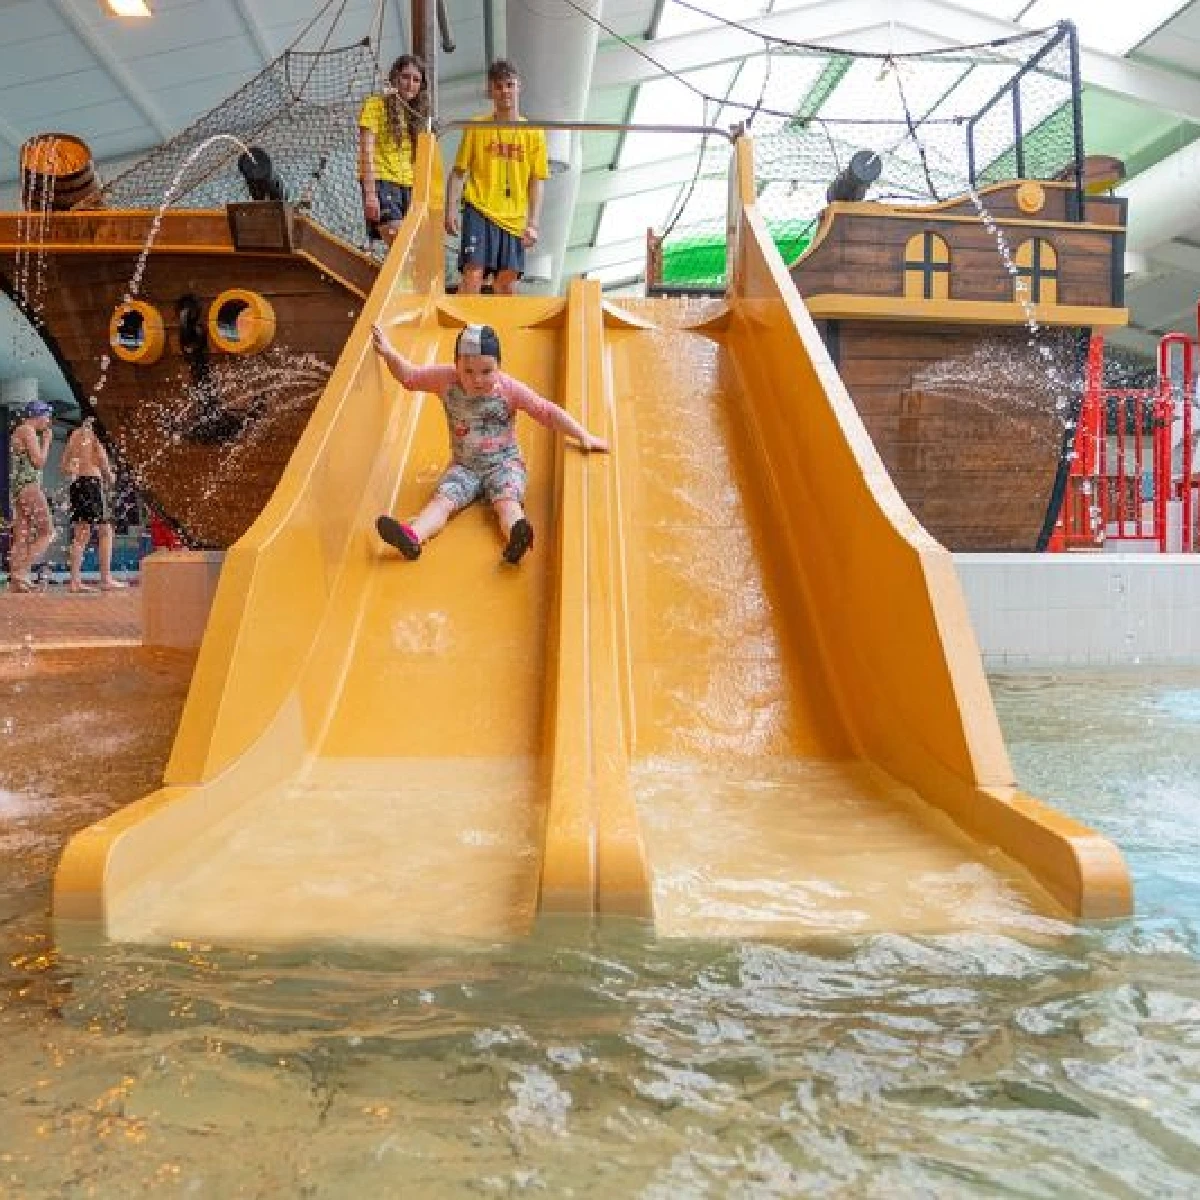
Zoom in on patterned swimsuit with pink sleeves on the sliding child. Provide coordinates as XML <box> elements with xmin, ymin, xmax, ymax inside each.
<box><xmin>404</xmin><ymin>366</ymin><xmax>575</xmax><ymax>512</ymax></box>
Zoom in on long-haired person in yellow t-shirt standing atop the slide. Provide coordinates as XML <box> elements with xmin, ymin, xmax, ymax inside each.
<box><xmin>359</xmin><ymin>54</ymin><xmax>430</xmax><ymax>246</ymax></box>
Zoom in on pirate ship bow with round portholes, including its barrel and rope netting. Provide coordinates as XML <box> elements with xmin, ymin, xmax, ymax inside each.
<box><xmin>0</xmin><ymin>32</ymin><xmax>379</xmax><ymax>547</ymax></box>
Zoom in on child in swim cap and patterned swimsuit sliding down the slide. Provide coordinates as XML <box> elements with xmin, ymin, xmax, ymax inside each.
<box><xmin>371</xmin><ymin>324</ymin><xmax>608</xmax><ymax>565</ymax></box>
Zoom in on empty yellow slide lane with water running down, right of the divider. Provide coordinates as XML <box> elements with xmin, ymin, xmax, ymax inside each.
<box><xmin>606</xmin><ymin>300</ymin><xmax>1055</xmax><ymax>936</ymax></box>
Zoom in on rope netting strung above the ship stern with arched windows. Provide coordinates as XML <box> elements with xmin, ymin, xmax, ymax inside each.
<box><xmin>647</xmin><ymin>18</ymin><xmax>1082</xmax><ymax>290</ymax></box>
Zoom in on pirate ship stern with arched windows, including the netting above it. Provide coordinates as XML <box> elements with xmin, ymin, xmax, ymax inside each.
<box><xmin>647</xmin><ymin>23</ymin><xmax>1128</xmax><ymax>551</ymax></box>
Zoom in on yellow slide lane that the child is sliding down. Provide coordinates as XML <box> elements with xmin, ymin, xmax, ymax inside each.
<box><xmin>102</xmin><ymin>300</ymin><xmax>564</xmax><ymax>946</ymax></box>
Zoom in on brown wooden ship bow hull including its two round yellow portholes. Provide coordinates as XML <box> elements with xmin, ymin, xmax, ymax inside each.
<box><xmin>0</xmin><ymin>200</ymin><xmax>378</xmax><ymax>548</ymax></box>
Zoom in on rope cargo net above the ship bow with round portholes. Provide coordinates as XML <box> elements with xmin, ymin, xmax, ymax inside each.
<box><xmin>102</xmin><ymin>41</ymin><xmax>382</xmax><ymax>253</ymax></box>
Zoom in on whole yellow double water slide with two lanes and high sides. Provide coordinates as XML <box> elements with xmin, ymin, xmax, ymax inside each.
<box><xmin>54</xmin><ymin>138</ymin><xmax>1130</xmax><ymax>946</ymax></box>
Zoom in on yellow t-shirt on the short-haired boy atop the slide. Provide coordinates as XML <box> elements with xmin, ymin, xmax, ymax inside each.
<box><xmin>454</xmin><ymin>113</ymin><xmax>550</xmax><ymax>238</ymax></box>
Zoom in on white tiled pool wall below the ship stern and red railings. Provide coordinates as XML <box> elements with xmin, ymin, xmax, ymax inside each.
<box><xmin>954</xmin><ymin>553</ymin><xmax>1200</xmax><ymax>670</ymax></box>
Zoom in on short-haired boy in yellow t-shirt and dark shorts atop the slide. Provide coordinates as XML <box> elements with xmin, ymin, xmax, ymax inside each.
<box><xmin>446</xmin><ymin>59</ymin><xmax>550</xmax><ymax>295</ymax></box>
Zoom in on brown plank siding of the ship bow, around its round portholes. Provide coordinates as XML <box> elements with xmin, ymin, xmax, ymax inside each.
<box><xmin>0</xmin><ymin>212</ymin><xmax>377</xmax><ymax>547</ymax></box>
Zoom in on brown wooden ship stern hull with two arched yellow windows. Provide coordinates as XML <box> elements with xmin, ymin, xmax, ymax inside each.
<box><xmin>791</xmin><ymin>181</ymin><xmax>1128</xmax><ymax>551</ymax></box>
